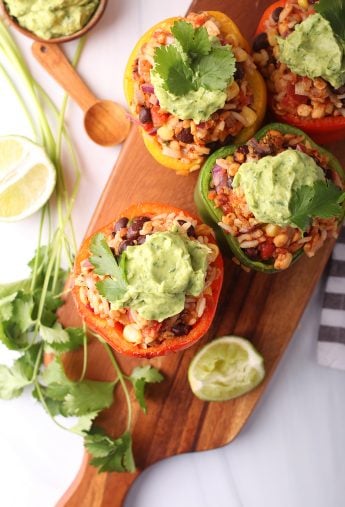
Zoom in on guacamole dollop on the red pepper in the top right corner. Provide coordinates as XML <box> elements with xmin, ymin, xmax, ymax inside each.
<box><xmin>277</xmin><ymin>14</ymin><xmax>345</xmax><ymax>88</ymax></box>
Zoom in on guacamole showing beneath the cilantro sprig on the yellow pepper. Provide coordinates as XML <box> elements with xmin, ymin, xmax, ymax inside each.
<box><xmin>151</xmin><ymin>70</ymin><xmax>226</xmax><ymax>124</ymax></box>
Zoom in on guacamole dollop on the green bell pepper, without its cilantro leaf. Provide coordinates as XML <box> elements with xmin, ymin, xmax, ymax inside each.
<box><xmin>233</xmin><ymin>149</ymin><xmax>325</xmax><ymax>226</ymax></box>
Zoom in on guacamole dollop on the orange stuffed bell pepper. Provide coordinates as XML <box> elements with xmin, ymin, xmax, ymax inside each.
<box><xmin>111</xmin><ymin>231</ymin><xmax>210</xmax><ymax>322</ymax></box>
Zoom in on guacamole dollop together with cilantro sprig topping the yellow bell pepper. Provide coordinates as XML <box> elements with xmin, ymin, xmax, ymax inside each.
<box><xmin>151</xmin><ymin>21</ymin><xmax>236</xmax><ymax>123</ymax></box>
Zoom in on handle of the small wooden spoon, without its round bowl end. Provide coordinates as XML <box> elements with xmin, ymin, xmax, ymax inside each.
<box><xmin>32</xmin><ymin>42</ymin><xmax>97</xmax><ymax>111</ymax></box>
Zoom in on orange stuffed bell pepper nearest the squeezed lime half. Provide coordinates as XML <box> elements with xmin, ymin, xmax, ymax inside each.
<box><xmin>73</xmin><ymin>203</ymin><xmax>223</xmax><ymax>358</ymax></box>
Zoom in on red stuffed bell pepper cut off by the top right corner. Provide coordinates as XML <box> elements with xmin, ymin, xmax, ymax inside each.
<box><xmin>253</xmin><ymin>0</ymin><xmax>345</xmax><ymax>144</ymax></box>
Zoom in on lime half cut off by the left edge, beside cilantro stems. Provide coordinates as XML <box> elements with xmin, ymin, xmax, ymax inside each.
<box><xmin>0</xmin><ymin>136</ymin><xmax>56</xmax><ymax>222</ymax></box>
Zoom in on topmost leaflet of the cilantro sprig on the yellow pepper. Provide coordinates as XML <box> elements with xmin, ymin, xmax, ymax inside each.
<box><xmin>171</xmin><ymin>21</ymin><xmax>211</xmax><ymax>58</ymax></box>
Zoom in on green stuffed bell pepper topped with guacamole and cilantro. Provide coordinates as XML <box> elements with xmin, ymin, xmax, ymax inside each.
<box><xmin>195</xmin><ymin>123</ymin><xmax>345</xmax><ymax>273</ymax></box>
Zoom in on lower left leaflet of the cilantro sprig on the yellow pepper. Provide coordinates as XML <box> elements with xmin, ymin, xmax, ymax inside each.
<box><xmin>154</xmin><ymin>45</ymin><xmax>194</xmax><ymax>96</ymax></box>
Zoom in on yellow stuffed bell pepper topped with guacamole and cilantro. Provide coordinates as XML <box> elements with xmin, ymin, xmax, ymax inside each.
<box><xmin>124</xmin><ymin>11</ymin><xmax>266</xmax><ymax>174</ymax></box>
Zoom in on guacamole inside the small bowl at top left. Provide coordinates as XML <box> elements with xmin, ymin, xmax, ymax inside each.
<box><xmin>5</xmin><ymin>0</ymin><xmax>99</xmax><ymax>39</ymax></box>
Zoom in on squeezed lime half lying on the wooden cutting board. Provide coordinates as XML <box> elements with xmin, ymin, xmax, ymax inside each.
<box><xmin>188</xmin><ymin>336</ymin><xmax>265</xmax><ymax>401</ymax></box>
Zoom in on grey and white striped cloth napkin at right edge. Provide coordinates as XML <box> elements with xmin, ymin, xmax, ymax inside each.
<box><xmin>317</xmin><ymin>226</ymin><xmax>345</xmax><ymax>370</ymax></box>
